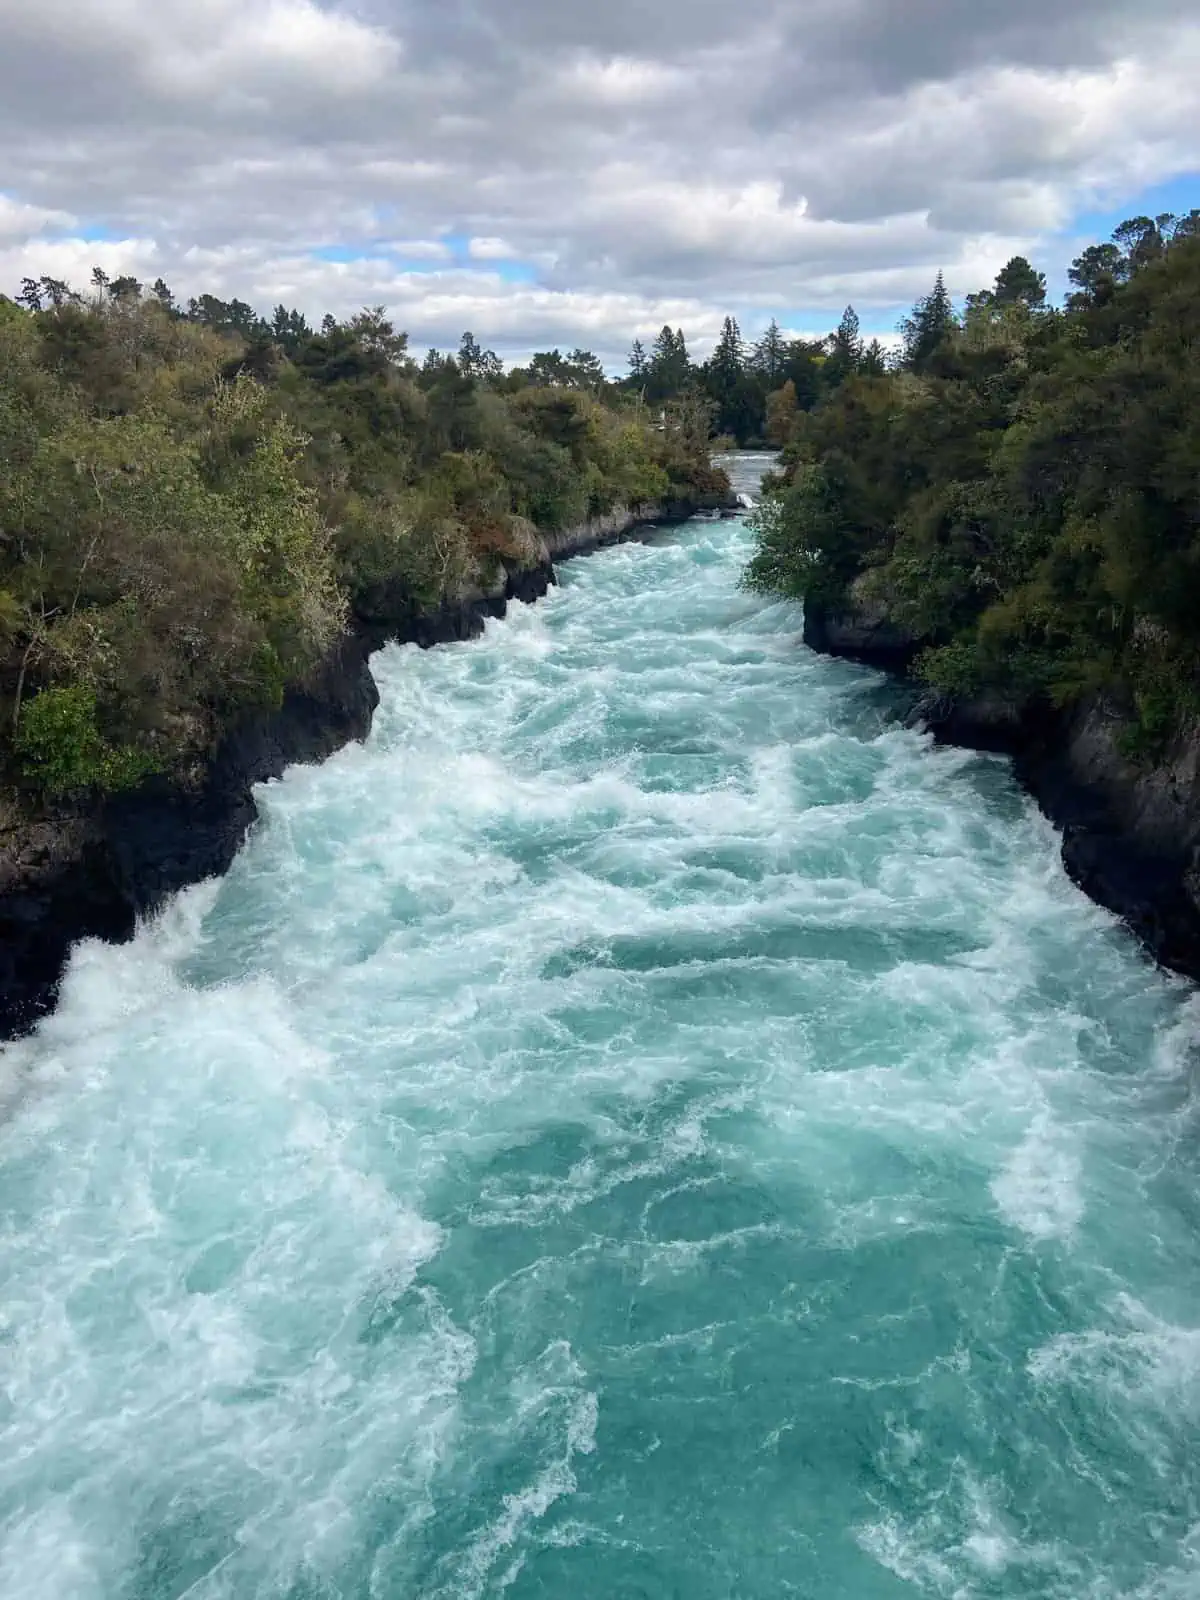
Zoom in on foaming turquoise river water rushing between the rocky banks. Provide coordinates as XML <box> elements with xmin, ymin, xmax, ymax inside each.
<box><xmin>0</xmin><ymin>461</ymin><xmax>1200</xmax><ymax>1600</ymax></box>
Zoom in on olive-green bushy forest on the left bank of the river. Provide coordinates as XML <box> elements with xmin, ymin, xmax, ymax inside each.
<box><xmin>0</xmin><ymin>280</ymin><xmax>728</xmax><ymax>800</ymax></box>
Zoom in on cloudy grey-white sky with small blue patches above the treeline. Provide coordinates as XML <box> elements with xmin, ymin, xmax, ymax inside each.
<box><xmin>0</xmin><ymin>0</ymin><xmax>1200</xmax><ymax>370</ymax></box>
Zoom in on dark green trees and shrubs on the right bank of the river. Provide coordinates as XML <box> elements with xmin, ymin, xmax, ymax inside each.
<box><xmin>747</xmin><ymin>211</ymin><xmax>1200</xmax><ymax>754</ymax></box>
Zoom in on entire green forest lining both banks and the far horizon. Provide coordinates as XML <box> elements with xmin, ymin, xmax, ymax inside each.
<box><xmin>0</xmin><ymin>211</ymin><xmax>1200</xmax><ymax>795</ymax></box>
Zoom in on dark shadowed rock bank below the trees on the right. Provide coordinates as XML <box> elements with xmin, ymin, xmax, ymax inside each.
<box><xmin>805</xmin><ymin>600</ymin><xmax>1200</xmax><ymax>979</ymax></box>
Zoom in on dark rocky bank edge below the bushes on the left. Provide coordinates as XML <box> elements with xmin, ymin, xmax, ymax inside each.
<box><xmin>0</xmin><ymin>501</ymin><xmax>713</xmax><ymax>1038</ymax></box>
